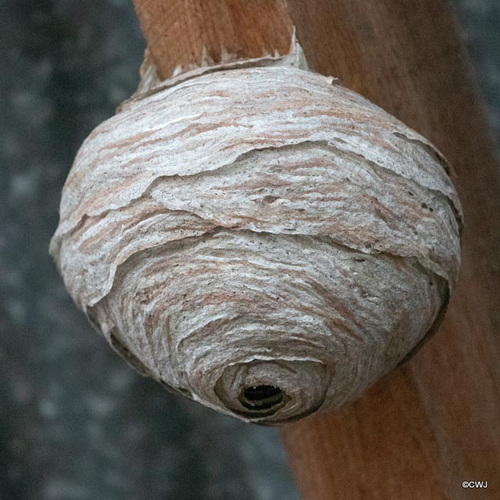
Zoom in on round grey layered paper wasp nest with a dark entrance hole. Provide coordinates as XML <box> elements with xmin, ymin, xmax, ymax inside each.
<box><xmin>51</xmin><ymin>45</ymin><xmax>461</xmax><ymax>424</ymax></box>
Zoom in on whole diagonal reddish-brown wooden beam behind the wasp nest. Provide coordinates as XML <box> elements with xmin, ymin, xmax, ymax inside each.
<box><xmin>130</xmin><ymin>0</ymin><xmax>500</xmax><ymax>500</ymax></box>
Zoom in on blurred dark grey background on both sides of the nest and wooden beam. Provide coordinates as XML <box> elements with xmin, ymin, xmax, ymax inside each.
<box><xmin>0</xmin><ymin>0</ymin><xmax>500</xmax><ymax>500</ymax></box>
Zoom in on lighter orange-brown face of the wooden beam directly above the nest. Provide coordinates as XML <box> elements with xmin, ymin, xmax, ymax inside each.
<box><xmin>134</xmin><ymin>0</ymin><xmax>293</xmax><ymax>78</ymax></box>
